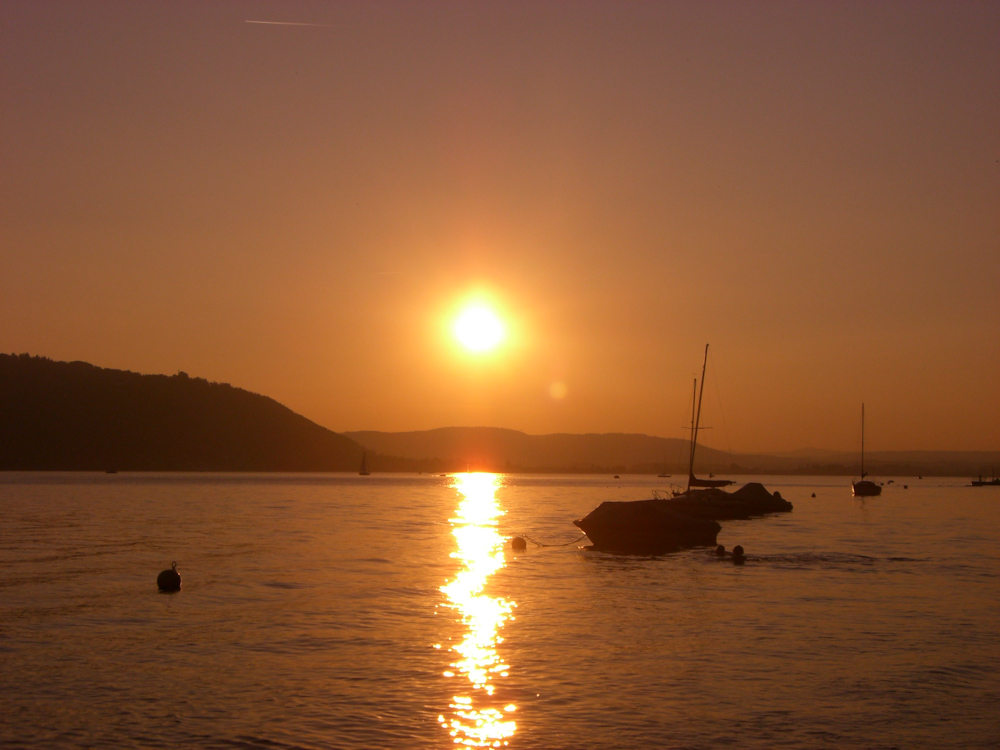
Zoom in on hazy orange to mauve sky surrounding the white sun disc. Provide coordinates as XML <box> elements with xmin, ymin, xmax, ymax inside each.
<box><xmin>0</xmin><ymin>0</ymin><xmax>1000</xmax><ymax>451</ymax></box>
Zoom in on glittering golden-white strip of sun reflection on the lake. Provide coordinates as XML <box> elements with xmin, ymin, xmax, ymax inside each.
<box><xmin>438</xmin><ymin>474</ymin><xmax>517</xmax><ymax>747</ymax></box>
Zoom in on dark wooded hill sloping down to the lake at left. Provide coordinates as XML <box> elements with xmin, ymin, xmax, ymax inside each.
<box><xmin>0</xmin><ymin>354</ymin><xmax>364</xmax><ymax>471</ymax></box>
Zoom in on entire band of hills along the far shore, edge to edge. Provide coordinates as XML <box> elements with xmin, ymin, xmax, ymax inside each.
<box><xmin>0</xmin><ymin>354</ymin><xmax>1000</xmax><ymax>482</ymax></box>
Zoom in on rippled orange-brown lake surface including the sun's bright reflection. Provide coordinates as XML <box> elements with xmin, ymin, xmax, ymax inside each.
<box><xmin>0</xmin><ymin>473</ymin><xmax>1000</xmax><ymax>750</ymax></box>
